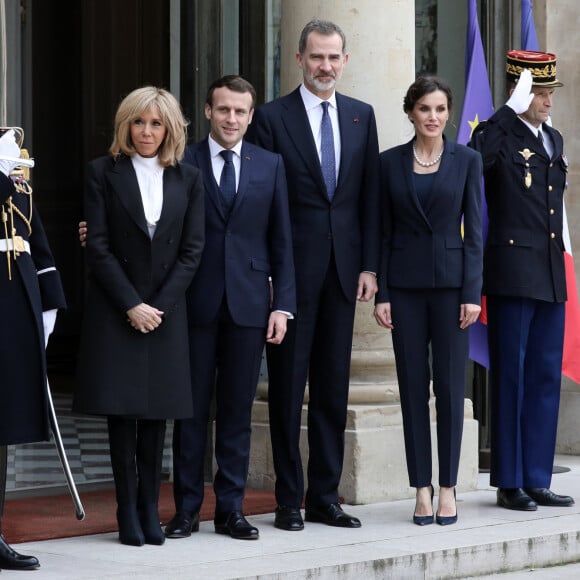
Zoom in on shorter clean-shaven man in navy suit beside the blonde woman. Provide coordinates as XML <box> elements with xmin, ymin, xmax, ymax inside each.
<box><xmin>165</xmin><ymin>76</ymin><xmax>296</xmax><ymax>539</ymax></box>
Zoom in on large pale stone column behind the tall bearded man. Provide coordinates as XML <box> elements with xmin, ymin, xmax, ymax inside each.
<box><xmin>248</xmin><ymin>0</ymin><xmax>478</xmax><ymax>503</ymax></box>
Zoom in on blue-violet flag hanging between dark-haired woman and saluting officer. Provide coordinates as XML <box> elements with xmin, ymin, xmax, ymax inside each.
<box><xmin>457</xmin><ymin>0</ymin><xmax>493</xmax><ymax>368</ymax></box>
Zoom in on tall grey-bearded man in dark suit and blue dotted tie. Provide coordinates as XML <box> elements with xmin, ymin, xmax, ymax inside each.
<box><xmin>248</xmin><ymin>20</ymin><xmax>380</xmax><ymax>531</ymax></box>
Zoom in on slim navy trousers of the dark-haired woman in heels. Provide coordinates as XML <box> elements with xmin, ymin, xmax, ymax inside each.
<box><xmin>391</xmin><ymin>288</ymin><xmax>469</xmax><ymax>487</ymax></box>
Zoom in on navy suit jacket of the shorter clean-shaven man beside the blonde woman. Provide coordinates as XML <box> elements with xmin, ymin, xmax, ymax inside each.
<box><xmin>184</xmin><ymin>138</ymin><xmax>296</xmax><ymax>327</ymax></box>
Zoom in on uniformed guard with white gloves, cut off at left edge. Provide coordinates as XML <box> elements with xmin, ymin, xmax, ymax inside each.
<box><xmin>0</xmin><ymin>129</ymin><xmax>66</xmax><ymax>570</ymax></box>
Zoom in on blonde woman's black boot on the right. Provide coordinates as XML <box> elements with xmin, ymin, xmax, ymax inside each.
<box><xmin>136</xmin><ymin>419</ymin><xmax>165</xmax><ymax>546</ymax></box>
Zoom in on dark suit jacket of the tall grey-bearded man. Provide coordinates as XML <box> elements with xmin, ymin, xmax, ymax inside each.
<box><xmin>248</xmin><ymin>88</ymin><xmax>380</xmax><ymax>302</ymax></box>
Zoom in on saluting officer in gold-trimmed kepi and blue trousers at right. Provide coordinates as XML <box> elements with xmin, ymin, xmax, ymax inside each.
<box><xmin>471</xmin><ymin>50</ymin><xmax>574</xmax><ymax>511</ymax></box>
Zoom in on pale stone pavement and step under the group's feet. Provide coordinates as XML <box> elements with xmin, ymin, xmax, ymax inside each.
<box><xmin>0</xmin><ymin>456</ymin><xmax>580</xmax><ymax>580</ymax></box>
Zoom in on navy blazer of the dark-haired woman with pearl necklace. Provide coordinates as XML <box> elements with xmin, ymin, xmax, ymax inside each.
<box><xmin>375</xmin><ymin>139</ymin><xmax>483</xmax><ymax>304</ymax></box>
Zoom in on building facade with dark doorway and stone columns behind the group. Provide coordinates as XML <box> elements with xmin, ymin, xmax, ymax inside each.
<box><xmin>0</xmin><ymin>0</ymin><xmax>580</xmax><ymax>502</ymax></box>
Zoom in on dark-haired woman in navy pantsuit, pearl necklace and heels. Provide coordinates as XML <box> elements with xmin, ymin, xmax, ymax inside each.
<box><xmin>375</xmin><ymin>77</ymin><xmax>482</xmax><ymax>525</ymax></box>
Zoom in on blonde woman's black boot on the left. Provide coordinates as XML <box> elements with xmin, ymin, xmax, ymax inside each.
<box><xmin>107</xmin><ymin>416</ymin><xmax>145</xmax><ymax>546</ymax></box>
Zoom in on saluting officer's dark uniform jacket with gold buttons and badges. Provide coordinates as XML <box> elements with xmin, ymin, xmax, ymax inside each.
<box><xmin>470</xmin><ymin>105</ymin><xmax>568</xmax><ymax>302</ymax></box>
